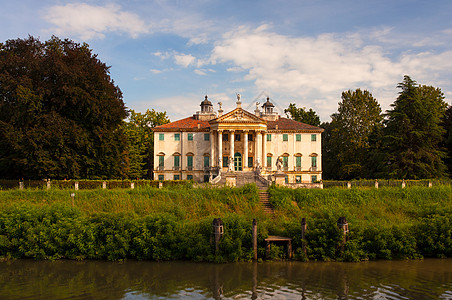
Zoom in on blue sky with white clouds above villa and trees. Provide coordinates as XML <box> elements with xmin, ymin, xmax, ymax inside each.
<box><xmin>0</xmin><ymin>0</ymin><xmax>452</xmax><ymax>121</ymax></box>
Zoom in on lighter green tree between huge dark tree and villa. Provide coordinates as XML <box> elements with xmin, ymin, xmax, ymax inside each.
<box><xmin>123</xmin><ymin>109</ymin><xmax>170</xmax><ymax>178</ymax></box>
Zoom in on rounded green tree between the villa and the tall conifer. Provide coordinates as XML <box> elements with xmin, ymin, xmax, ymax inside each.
<box><xmin>324</xmin><ymin>89</ymin><xmax>383</xmax><ymax>179</ymax></box>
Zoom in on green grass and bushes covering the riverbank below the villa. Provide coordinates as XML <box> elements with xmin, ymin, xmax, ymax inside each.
<box><xmin>0</xmin><ymin>184</ymin><xmax>452</xmax><ymax>262</ymax></box>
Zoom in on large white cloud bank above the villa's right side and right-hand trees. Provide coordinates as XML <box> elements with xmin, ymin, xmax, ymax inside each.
<box><xmin>211</xmin><ymin>26</ymin><xmax>452</xmax><ymax>120</ymax></box>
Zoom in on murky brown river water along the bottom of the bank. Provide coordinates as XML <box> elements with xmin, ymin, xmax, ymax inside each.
<box><xmin>0</xmin><ymin>259</ymin><xmax>452</xmax><ymax>300</ymax></box>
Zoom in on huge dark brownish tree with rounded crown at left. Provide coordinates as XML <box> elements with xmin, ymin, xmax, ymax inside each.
<box><xmin>0</xmin><ymin>36</ymin><xmax>127</xmax><ymax>178</ymax></box>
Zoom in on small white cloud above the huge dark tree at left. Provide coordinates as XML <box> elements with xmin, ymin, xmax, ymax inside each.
<box><xmin>44</xmin><ymin>3</ymin><xmax>150</xmax><ymax>40</ymax></box>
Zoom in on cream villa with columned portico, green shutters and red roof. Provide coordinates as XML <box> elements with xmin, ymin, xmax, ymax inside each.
<box><xmin>154</xmin><ymin>95</ymin><xmax>323</xmax><ymax>183</ymax></box>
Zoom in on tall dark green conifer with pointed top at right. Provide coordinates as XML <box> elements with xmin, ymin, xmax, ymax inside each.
<box><xmin>383</xmin><ymin>76</ymin><xmax>447</xmax><ymax>179</ymax></box>
